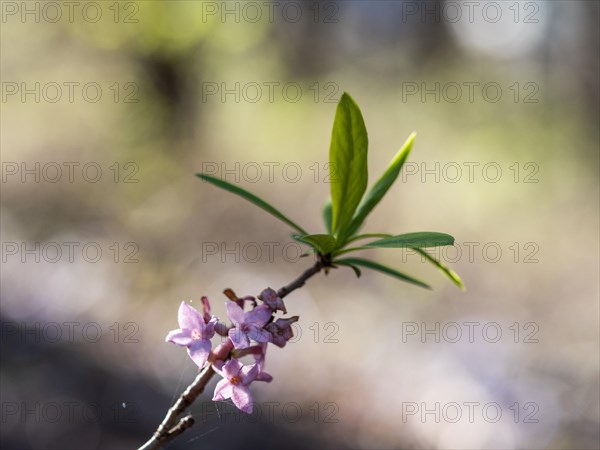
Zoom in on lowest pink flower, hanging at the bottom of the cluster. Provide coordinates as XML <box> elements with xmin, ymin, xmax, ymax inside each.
<box><xmin>213</xmin><ymin>359</ymin><xmax>272</xmax><ymax>414</ymax></box>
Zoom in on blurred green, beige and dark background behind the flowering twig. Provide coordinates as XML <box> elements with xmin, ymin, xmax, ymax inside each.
<box><xmin>0</xmin><ymin>1</ymin><xmax>600</xmax><ymax>449</ymax></box>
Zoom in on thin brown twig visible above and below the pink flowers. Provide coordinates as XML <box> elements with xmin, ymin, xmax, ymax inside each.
<box><xmin>138</xmin><ymin>258</ymin><xmax>327</xmax><ymax>450</ymax></box>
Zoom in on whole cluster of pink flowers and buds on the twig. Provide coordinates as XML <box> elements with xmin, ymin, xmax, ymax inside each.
<box><xmin>166</xmin><ymin>288</ymin><xmax>298</xmax><ymax>414</ymax></box>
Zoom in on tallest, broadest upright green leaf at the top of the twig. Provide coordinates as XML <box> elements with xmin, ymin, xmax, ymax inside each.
<box><xmin>329</xmin><ymin>92</ymin><xmax>368</xmax><ymax>236</ymax></box>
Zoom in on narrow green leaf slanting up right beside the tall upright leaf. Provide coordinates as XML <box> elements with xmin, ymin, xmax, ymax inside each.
<box><xmin>347</xmin><ymin>132</ymin><xmax>417</xmax><ymax>236</ymax></box>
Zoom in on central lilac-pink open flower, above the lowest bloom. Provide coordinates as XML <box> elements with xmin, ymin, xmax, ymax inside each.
<box><xmin>226</xmin><ymin>301</ymin><xmax>271</xmax><ymax>348</ymax></box>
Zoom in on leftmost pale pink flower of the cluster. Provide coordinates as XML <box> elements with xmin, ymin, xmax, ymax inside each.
<box><xmin>165</xmin><ymin>302</ymin><xmax>218</xmax><ymax>368</ymax></box>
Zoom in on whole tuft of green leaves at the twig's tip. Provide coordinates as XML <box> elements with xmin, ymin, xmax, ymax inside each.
<box><xmin>197</xmin><ymin>93</ymin><xmax>464</xmax><ymax>289</ymax></box>
